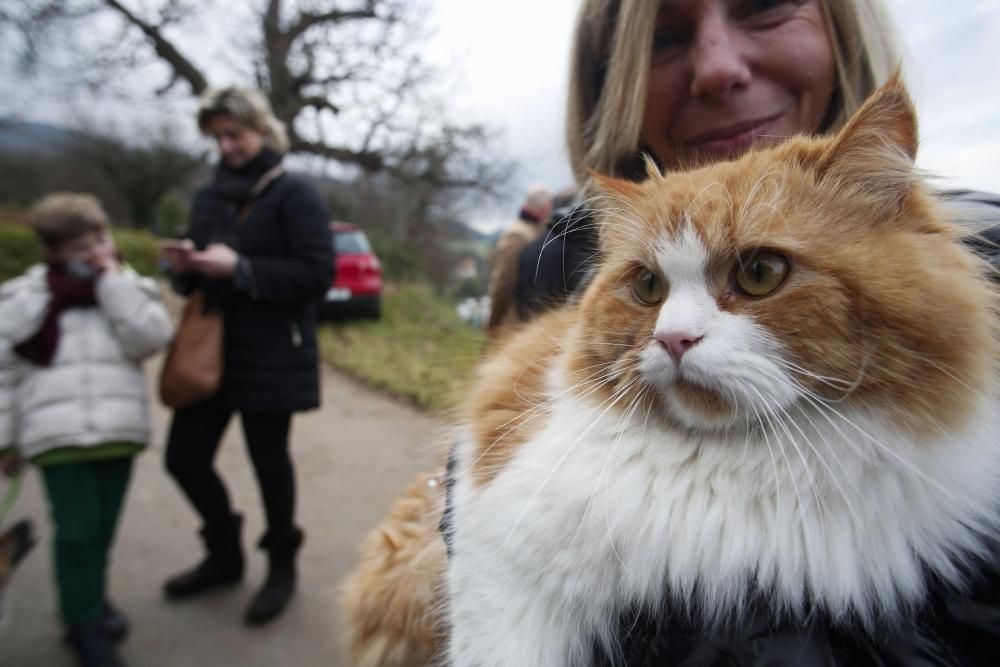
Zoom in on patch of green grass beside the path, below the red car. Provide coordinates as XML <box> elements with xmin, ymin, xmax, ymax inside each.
<box><xmin>320</xmin><ymin>284</ymin><xmax>486</xmax><ymax>412</ymax></box>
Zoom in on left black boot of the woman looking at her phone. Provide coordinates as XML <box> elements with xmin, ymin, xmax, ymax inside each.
<box><xmin>163</xmin><ymin>514</ymin><xmax>243</xmax><ymax>600</ymax></box>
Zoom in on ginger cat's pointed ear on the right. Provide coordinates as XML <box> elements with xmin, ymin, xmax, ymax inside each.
<box><xmin>818</xmin><ymin>70</ymin><xmax>918</xmax><ymax>209</ymax></box>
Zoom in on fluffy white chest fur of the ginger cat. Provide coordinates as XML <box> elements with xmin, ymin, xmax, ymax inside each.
<box><xmin>448</xmin><ymin>384</ymin><xmax>1000</xmax><ymax>666</ymax></box>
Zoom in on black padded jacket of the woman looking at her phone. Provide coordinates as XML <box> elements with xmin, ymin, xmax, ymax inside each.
<box><xmin>175</xmin><ymin>149</ymin><xmax>334</xmax><ymax>412</ymax></box>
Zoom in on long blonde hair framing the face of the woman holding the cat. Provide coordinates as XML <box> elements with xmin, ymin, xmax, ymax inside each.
<box><xmin>566</xmin><ymin>0</ymin><xmax>899</xmax><ymax>183</ymax></box>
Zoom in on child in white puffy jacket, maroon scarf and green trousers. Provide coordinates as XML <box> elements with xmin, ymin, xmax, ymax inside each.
<box><xmin>0</xmin><ymin>194</ymin><xmax>173</xmax><ymax>667</ymax></box>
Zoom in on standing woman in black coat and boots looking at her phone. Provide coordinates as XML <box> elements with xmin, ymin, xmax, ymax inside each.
<box><xmin>158</xmin><ymin>88</ymin><xmax>334</xmax><ymax>625</ymax></box>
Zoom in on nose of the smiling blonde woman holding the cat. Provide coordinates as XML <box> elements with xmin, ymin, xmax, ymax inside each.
<box><xmin>690</xmin><ymin>8</ymin><xmax>750</xmax><ymax>98</ymax></box>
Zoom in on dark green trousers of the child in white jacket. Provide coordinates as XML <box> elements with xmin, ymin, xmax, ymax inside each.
<box><xmin>40</xmin><ymin>456</ymin><xmax>132</xmax><ymax>625</ymax></box>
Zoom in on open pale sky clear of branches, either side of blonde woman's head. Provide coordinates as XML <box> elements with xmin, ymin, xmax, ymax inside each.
<box><xmin>431</xmin><ymin>0</ymin><xmax>1000</xmax><ymax>234</ymax></box>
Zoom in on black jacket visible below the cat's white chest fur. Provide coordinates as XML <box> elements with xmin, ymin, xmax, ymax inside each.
<box><xmin>591</xmin><ymin>567</ymin><xmax>1000</xmax><ymax>667</ymax></box>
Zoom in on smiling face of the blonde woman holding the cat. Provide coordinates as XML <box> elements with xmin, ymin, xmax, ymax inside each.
<box><xmin>642</xmin><ymin>0</ymin><xmax>835</xmax><ymax>167</ymax></box>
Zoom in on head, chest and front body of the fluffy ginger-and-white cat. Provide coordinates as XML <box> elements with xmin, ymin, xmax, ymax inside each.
<box><xmin>446</xmin><ymin>81</ymin><xmax>1000</xmax><ymax>667</ymax></box>
